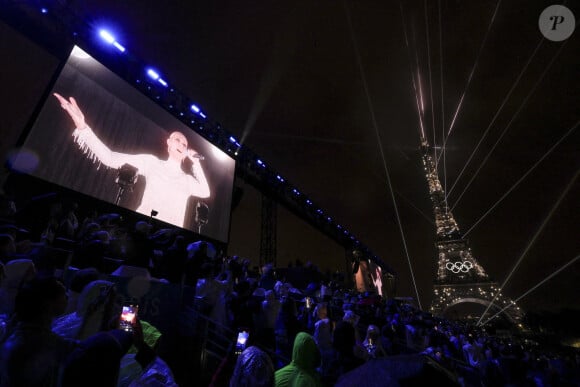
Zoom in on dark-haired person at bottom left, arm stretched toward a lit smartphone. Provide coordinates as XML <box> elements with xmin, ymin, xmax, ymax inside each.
<box><xmin>0</xmin><ymin>277</ymin><xmax>154</xmax><ymax>387</ymax></box>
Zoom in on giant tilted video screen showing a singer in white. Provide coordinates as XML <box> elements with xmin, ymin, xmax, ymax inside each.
<box><xmin>13</xmin><ymin>47</ymin><xmax>235</xmax><ymax>242</ymax></box>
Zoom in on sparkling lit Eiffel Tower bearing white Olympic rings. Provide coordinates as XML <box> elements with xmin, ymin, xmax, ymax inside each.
<box><xmin>421</xmin><ymin>140</ymin><xmax>523</xmax><ymax>323</ymax></box>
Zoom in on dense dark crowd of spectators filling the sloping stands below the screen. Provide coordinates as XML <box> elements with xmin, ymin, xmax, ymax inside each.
<box><xmin>0</xmin><ymin>192</ymin><xmax>580</xmax><ymax>386</ymax></box>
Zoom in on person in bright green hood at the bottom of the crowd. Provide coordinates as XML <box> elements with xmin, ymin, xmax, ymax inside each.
<box><xmin>275</xmin><ymin>332</ymin><xmax>322</xmax><ymax>387</ymax></box>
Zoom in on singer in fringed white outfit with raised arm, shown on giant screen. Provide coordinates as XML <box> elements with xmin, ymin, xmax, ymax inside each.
<box><xmin>54</xmin><ymin>93</ymin><xmax>210</xmax><ymax>227</ymax></box>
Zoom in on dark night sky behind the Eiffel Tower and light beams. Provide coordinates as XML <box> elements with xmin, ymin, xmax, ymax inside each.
<box><xmin>1</xmin><ymin>0</ymin><xmax>580</xmax><ymax>310</ymax></box>
